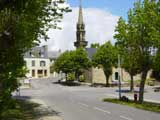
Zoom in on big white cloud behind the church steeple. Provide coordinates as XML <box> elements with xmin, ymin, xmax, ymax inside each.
<box><xmin>41</xmin><ymin>8</ymin><xmax>119</xmax><ymax>50</ymax></box>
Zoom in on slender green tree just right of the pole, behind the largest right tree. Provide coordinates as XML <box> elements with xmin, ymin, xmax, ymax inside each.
<box><xmin>114</xmin><ymin>13</ymin><xmax>139</xmax><ymax>92</ymax></box>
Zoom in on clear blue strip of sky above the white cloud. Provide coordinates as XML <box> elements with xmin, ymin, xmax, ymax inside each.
<box><xmin>67</xmin><ymin>0</ymin><xmax>136</xmax><ymax>19</ymax></box>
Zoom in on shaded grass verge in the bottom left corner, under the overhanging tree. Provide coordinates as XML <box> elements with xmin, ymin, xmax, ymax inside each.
<box><xmin>0</xmin><ymin>99</ymin><xmax>59</xmax><ymax>120</ymax></box>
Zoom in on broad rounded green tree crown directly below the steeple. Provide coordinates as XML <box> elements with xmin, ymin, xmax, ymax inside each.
<box><xmin>54</xmin><ymin>48</ymin><xmax>91</xmax><ymax>79</ymax></box>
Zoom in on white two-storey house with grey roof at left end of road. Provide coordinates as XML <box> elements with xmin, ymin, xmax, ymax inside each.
<box><xmin>24</xmin><ymin>46</ymin><xmax>50</xmax><ymax>78</ymax></box>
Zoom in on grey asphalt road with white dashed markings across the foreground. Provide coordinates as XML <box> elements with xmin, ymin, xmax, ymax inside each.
<box><xmin>21</xmin><ymin>79</ymin><xmax>160</xmax><ymax>120</ymax></box>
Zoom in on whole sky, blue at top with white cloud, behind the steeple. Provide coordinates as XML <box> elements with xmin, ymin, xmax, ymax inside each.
<box><xmin>41</xmin><ymin>0</ymin><xmax>136</xmax><ymax>51</ymax></box>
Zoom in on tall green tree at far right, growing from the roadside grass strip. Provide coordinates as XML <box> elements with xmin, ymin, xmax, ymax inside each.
<box><xmin>115</xmin><ymin>0</ymin><xmax>160</xmax><ymax>103</ymax></box>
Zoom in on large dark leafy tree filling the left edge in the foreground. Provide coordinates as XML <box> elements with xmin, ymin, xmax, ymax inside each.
<box><xmin>0</xmin><ymin>0</ymin><xmax>69</xmax><ymax>113</ymax></box>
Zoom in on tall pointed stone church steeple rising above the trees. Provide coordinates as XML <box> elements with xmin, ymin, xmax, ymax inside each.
<box><xmin>74</xmin><ymin>0</ymin><xmax>87</xmax><ymax>48</ymax></box>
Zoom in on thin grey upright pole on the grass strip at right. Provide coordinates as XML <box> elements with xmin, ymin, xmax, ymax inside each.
<box><xmin>118</xmin><ymin>55</ymin><xmax>121</xmax><ymax>99</ymax></box>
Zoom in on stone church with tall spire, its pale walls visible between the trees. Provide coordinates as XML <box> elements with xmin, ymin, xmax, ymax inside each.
<box><xmin>74</xmin><ymin>0</ymin><xmax>151</xmax><ymax>84</ymax></box>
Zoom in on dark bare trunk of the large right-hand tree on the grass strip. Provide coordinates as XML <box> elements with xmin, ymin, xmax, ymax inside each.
<box><xmin>139</xmin><ymin>71</ymin><xmax>148</xmax><ymax>103</ymax></box>
